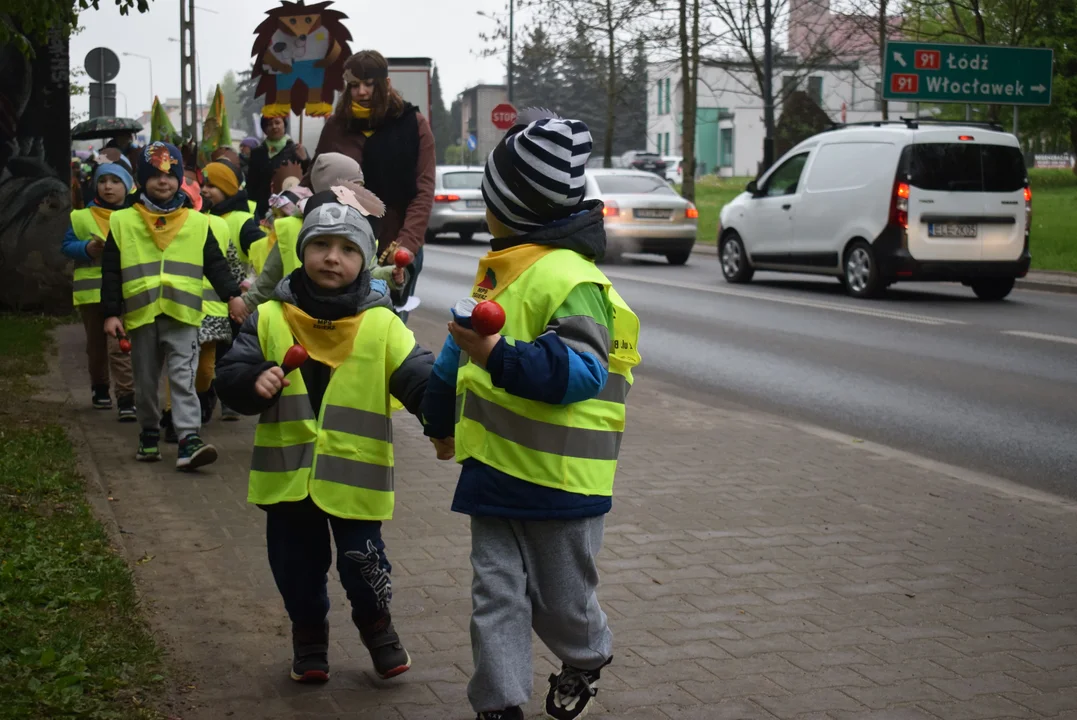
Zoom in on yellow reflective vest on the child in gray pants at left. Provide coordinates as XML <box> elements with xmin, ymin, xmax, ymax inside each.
<box><xmin>110</xmin><ymin>206</ymin><xmax>209</xmax><ymax>331</ymax></box>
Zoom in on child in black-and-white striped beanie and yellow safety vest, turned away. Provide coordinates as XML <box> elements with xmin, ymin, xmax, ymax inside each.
<box><xmin>423</xmin><ymin>111</ymin><xmax>640</xmax><ymax>720</ymax></box>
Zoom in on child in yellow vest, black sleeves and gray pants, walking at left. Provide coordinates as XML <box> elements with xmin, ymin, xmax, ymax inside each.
<box><xmin>101</xmin><ymin>142</ymin><xmax>242</xmax><ymax>470</ymax></box>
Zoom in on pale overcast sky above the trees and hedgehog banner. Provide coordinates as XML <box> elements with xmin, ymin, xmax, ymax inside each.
<box><xmin>70</xmin><ymin>0</ymin><xmax>505</xmax><ymax>117</ymax></box>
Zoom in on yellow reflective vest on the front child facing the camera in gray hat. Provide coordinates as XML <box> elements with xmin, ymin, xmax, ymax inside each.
<box><xmin>248</xmin><ymin>300</ymin><xmax>415</xmax><ymax>520</ymax></box>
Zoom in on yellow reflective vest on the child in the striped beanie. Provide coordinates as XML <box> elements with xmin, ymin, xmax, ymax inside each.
<box><xmin>456</xmin><ymin>250</ymin><xmax>640</xmax><ymax>496</ymax></box>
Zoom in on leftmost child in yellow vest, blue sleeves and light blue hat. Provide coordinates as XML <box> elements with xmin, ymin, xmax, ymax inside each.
<box><xmin>61</xmin><ymin>163</ymin><xmax>135</xmax><ymax>422</ymax></box>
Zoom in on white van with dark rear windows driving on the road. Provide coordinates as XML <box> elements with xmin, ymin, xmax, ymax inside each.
<box><xmin>718</xmin><ymin>119</ymin><xmax>1032</xmax><ymax>300</ymax></box>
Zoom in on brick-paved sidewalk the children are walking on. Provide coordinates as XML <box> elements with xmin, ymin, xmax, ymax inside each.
<box><xmin>59</xmin><ymin>313</ymin><xmax>1077</xmax><ymax>720</ymax></box>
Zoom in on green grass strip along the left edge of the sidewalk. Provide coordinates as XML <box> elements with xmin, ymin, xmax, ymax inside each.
<box><xmin>0</xmin><ymin>314</ymin><xmax>164</xmax><ymax>720</ymax></box>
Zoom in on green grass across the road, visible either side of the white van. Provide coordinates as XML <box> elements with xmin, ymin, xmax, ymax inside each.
<box><xmin>696</xmin><ymin>170</ymin><xmax>1077</xmax><ymax>271</ymax></box>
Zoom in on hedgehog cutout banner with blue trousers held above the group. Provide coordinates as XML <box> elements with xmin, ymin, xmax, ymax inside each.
<box><xmin>251</xmin><ymin>0</ymin><xmax>351</xmax><ymax>119</ymax></box>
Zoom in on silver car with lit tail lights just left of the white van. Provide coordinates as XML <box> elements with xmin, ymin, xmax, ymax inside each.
<box><xmin>586</xmin><ymin>169</ymin><xmax>699</xmax><ymax>265</ymax></box>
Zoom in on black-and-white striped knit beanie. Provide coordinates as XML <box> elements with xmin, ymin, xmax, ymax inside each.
<box><xmin>482</xmin><ymin>109</ymin><xmax>591</xmax><ymax>235</ymax></box>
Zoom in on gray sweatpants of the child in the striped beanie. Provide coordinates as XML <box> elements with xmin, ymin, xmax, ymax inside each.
<box><xmin>467</xmin><ymin>516</ymin><xmax>613</xmax><ymax>712</ymax></box>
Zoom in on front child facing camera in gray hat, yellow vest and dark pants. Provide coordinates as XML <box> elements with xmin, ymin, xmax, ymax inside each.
<box><xmin>216</xmin><ymin>188</ymin><xmax>433</xmax><ymax>682</ymax></box>
